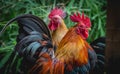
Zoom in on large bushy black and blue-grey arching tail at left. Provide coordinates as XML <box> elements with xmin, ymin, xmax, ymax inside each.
<box><xmin>0</xmin><ymin>14</ymin><xmax>54</xmax><ymax>74</ymax></box>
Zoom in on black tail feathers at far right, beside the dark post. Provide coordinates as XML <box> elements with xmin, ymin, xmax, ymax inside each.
<box><xmin>90</xmin><ymin>37</ymin><xmax>106</xmax><ymax>74</ymax></box>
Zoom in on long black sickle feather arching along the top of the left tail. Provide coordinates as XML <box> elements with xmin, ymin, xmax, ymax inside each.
<box><xmin>0</xmin><ymin>14</ymin><xmax>51</xmax><ymax>38</ymax></box>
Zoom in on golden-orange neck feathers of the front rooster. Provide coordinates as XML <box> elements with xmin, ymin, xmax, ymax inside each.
<box><xmin>55</xmin><ymin>27</ymin><xmax>92</xmax><ymax>65</ymax></box>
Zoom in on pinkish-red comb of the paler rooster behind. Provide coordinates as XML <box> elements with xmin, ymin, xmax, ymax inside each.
<box><xmin>48</xmin><ymin>8</ymin><xmax>66</xmax><ymax>18</ymax></box>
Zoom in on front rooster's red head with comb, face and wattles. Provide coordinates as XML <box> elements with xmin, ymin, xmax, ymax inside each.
<box><xmin>70</xmin><ymin>13</ymin><xmax>91</xmax><ymax>39</ymax></box>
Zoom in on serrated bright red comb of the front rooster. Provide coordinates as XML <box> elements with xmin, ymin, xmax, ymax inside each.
<box><xmin>70</xmin><ymin>13</ymin><xmax>91</xmax><ymax>27</ymax></box>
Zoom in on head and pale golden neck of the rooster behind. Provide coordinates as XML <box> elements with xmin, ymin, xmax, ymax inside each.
<box><xmin>48</xmin><ymin>7</ymin><xmax>68</xmax><ymax>47</ymax></box>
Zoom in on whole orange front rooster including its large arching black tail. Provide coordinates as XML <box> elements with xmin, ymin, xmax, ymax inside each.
<box><xmin>0</xmin><ymin>14</ymin><xmax>96</xmax><ymax>74</ymax></box>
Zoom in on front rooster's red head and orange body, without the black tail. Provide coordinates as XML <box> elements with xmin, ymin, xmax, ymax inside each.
<box><xmin>30</xmin><ymin>13</ymin><xmax>97</xmax><ymax>74</ymax></box>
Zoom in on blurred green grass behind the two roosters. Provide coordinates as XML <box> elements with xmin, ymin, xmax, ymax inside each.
<box><xmin>0</xmin><ymin>0</ymin><xmax>107</xmax><ymax>70</ymax></box>
